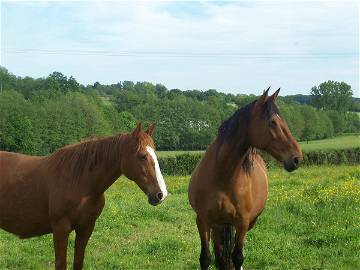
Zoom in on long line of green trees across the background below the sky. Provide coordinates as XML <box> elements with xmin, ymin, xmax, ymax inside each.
<box><xmin>0</xmin><ymin>68</ymin><xmax>360</xmax><ymax>155</ymax></box>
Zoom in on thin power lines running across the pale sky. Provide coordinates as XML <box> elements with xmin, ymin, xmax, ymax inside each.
<box><xmin>1</xmin><ymin>48</ymin><xmax>358</xmax><ymax>58</ymax></box>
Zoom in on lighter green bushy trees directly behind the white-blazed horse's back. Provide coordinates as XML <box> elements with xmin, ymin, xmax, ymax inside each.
<box><xmin>0</xmin><ymin>88</ymin><xmax>136</xmax><ymax>155</ymax></box>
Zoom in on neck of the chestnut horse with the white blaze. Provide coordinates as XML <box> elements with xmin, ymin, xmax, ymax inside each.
<box><xmin>45</xmin><ymin>135</ymin><xmax>126</xmax><ymax>194</ymax></box>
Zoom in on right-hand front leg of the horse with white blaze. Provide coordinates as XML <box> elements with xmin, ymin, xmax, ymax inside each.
<box><xmin>73</xmin><ymin>220</ymin><xmax>95</xmax><ymax>270</ymax></box>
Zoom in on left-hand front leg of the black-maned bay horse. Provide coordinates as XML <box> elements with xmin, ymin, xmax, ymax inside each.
<box><xmin>196</xmin><ymin>217</ymin><xmax>211</xmax><ymax>270</ymax></box>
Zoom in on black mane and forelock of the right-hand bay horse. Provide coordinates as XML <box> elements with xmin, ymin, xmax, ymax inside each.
<box><xmin>216</xmin><ymin>100</ymin><xmax>280</xmax><ymax>171</ymax></box>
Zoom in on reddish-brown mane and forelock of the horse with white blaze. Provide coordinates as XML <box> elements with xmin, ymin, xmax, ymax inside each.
<box><xmin>45</xmin><ymin>132</ymin><xmax>154</xmax><ymax>178</ymax></box>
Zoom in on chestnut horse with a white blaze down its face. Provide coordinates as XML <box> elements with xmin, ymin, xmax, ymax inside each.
<box><xmin>0</xmin><ymin>123</ymin><xmax>167</xmax><ymax>270</ymax></box>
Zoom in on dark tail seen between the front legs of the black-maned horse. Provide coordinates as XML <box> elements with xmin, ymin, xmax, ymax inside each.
<box><xmin>212</xmin><ymin>225</ymin><xmax>235</xmax><ymax>270</ymax></box>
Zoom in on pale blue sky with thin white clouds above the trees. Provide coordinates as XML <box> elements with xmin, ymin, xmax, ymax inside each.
<box><xmin>0</xmin><ymin>0</ymin><xmax>360</xmax><ymax>97</ymax></box>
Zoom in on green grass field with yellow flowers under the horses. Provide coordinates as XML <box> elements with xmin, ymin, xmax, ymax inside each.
<box><xmin>0</xmin><ymin>166</ymin><xmax>360</xmax><ymax>270</ymax></box>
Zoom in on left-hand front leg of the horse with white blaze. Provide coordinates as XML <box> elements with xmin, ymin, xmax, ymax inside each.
<box><xmin>52</xmin><ymin>219</ymin><xmax>71</xmax><ymax>270</ymax></box>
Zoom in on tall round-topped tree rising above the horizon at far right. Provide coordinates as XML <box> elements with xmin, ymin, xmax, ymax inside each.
<box><xmin>311</xmin><ymin>81</ymin><xmax>353</xmax><ymax>113</ymax></box>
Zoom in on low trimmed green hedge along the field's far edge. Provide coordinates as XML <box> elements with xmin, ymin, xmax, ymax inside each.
<box><xmin>159</xmin><ymin>147</ymin><xmax>360</xmax><ymax>175</ymax></box>
